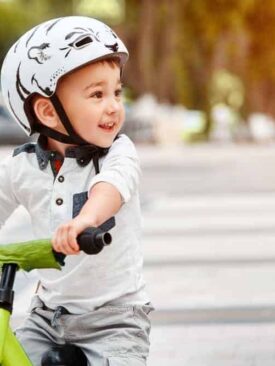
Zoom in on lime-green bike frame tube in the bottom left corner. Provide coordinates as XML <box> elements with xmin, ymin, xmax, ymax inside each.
<box><xmin>0</xmin><ymin>309</ymin><xmax>32</xmax><ymax>366</ymax></box>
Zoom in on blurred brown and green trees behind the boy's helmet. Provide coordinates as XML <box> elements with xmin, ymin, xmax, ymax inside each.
<box><xmin>0</xmin><ymin>0</ymin><xmax>275</xmax><ymax>126</ymax></box>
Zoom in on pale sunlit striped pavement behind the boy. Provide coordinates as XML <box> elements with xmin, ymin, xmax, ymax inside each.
<box><xmin>0</xmin><ymin>144</ymin><xmax>275</xmax><ymax>366</ymax></box>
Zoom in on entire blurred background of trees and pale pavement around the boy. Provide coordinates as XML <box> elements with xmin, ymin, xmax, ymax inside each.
<box><xmin>0</xmin><ymin>0</ymin><xmax>275</xmax><ymax>366</ymax></box>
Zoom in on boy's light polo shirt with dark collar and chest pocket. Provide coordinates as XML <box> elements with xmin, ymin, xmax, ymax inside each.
<box><xmin>0</xmin><ymin>135</ymin><xmax>149</xmax><ymax>314</ymax></box>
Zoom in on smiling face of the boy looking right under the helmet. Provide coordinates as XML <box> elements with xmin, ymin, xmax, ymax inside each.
<box><xmin>57</xmin><ymin>62</ymin><xmax>125</xmax><ymax>147</ymax></box>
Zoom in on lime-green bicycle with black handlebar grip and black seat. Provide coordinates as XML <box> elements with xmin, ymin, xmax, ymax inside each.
<box><xmin>0</xmin><ymin>218</ymin><xmax>115</xmax><ymax>366</ymax></box>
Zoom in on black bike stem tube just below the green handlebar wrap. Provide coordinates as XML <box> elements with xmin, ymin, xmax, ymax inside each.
<box><xmin>0</xmin><ymin>263</ymin><xmax>18</xmax><ymax>313</ymax></box>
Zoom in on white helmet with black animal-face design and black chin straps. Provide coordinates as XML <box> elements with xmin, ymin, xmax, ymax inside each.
<box><xmin>1</xmin><ymin>16</ymin><xmax>128</xmax><ymax>143</ymax></box>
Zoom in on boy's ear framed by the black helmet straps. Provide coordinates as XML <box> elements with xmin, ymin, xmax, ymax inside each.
<box><xmin>32</xmin><ymin>96</ymin><xmax>59</xmax><ymax>128</ymax></box>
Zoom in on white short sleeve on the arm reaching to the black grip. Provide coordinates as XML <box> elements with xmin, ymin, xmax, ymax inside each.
<box><xmin>89</xmin><ymin>135</ymin><xmax>140</xmax><ymax>203</ymax></box>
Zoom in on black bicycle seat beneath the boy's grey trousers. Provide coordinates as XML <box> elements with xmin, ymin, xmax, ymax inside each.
<box><xmin>41</xmin><ymin>344</ymin><xmax>88</xmax><ymax>366</ymax></box>
